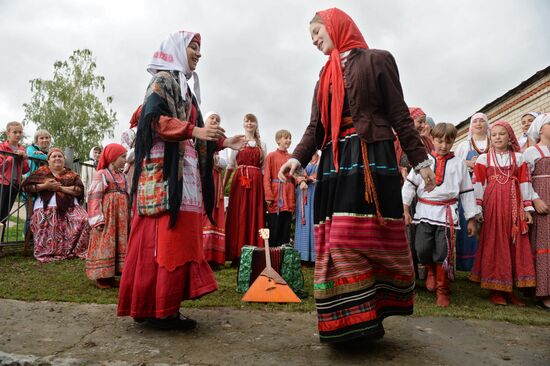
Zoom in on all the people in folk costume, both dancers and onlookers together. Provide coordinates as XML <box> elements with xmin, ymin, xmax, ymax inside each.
<box><xmin>0</xmin><ymin>8</ymin><xmax>550</xmax><ymax>343</ymax></box>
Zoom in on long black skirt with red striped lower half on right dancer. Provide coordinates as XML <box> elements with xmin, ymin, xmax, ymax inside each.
<box><xmin>314</xmin><ymin>133</ymin><xmax>414</xmax><ymax>343</ymax></box>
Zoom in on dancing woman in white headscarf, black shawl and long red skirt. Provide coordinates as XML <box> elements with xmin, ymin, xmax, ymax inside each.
<box><xmin>118</xmin><ymin>31</ymin><xmax>244</xmax><ymax>329</ymax></box>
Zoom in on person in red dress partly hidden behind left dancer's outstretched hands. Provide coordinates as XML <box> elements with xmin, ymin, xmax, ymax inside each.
<box><xmin>202</xmin><ymin>112</ymin><xmax>227</xmax><ymax>268</ymax></box>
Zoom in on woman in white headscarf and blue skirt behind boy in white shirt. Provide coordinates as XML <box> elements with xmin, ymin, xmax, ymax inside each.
<box><xmin>455</xmin><ymin>112</ymin><xmax>490</xmax><ymax>271</ymax></box>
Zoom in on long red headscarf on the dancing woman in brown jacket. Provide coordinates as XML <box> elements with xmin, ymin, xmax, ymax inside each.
<box><xmin>317</xmin><ymin>8</ymin><xmax>369</xmax><ymax>171</ymax></box>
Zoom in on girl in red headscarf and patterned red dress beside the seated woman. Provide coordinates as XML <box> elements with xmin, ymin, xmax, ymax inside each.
<box><xmin>86</xmin><ymin>144</ymin><xmax>129</xmax><ymax>289</ymax></box>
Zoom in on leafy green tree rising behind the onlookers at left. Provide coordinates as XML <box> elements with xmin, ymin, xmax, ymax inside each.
<box><xmin>23</xmin><ymin>49</ymin><xmax>117</xmax><ymax>159</ymax></box>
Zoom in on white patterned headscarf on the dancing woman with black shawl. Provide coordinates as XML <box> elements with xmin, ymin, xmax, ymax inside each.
<box><xmin>147</xmin><ymin>31</ymin><xmax>201</xmax><ymax>104</ymax></box>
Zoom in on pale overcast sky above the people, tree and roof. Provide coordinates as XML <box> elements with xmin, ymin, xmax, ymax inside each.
<box><xmin>0</xmin><ymin>0</ymin><xmax>550</xmax><ymax>154</ymax></box>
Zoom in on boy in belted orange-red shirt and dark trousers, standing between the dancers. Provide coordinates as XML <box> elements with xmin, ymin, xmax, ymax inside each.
<box><xmin>264</xmin><ymin>130</ymin><xmax>296</xmax><ymax>246</ymax></box>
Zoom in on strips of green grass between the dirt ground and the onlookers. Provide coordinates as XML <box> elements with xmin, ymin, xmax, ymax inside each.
<box><xmin>0</xmin><ymin>253</ymin><xmax>550</xmax><ymax>326</ymax></box>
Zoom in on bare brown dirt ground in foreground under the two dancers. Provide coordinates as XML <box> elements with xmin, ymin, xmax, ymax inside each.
<box><xmin>0</xmin><ymin>300</ymin><xmax>550</xmax><ymax>366</ymax></box>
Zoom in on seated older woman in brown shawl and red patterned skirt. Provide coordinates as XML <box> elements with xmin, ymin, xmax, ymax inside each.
<box><xmin>22</xmin><ymin>147</ymin><xmax>90</xmax><ymax>262</ymax></box>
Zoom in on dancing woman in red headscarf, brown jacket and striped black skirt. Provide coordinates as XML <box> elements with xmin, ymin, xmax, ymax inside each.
<box><xmin>279</xmin><ymin>8</ymin><xmax>435</xmax><ymax>343</ymax></box>
